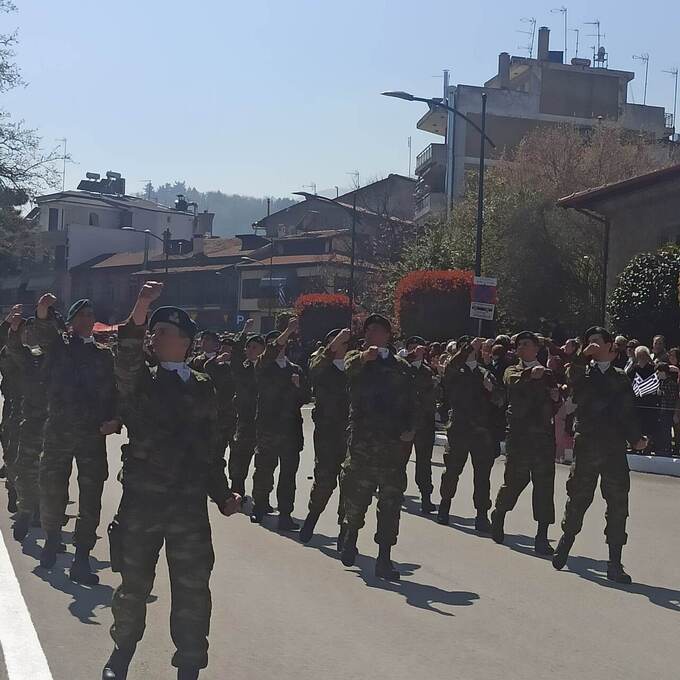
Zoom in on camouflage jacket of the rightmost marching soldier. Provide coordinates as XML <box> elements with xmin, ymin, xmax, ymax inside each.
<box><xmin>567</xmin><ymin>355</ymin><xmax>642</xmax><ymax>447</ymax></box>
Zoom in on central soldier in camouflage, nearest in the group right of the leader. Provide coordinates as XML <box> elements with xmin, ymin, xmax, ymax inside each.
<box><xmin>341</xmin><ymin>314</ymin><xmax>415</xmax><ymax>580</ymax></box>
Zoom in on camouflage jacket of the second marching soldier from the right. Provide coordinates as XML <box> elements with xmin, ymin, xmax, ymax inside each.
<box><xmin>503</xmin><ymin>363</ymin><xmax>559</xmax><ymax>437</ymax></box>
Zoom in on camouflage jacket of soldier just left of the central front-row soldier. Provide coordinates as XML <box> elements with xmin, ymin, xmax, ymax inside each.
<box><xmin>309</xmin><ymin>345</ymin><xmax>349</xmax><ymax>432</ymax></box>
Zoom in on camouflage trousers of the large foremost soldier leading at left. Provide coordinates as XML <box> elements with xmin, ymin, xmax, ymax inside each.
<box><xmin>111</xmin><ymin>489</ymin><xmax>215</xmax><ymax>668</ymax></box>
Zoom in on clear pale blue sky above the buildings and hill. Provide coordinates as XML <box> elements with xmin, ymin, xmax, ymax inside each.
<box><xmin>0</xmin><ymin>0</ymin><xmax>680</xmax><ymax>196</ymax></box>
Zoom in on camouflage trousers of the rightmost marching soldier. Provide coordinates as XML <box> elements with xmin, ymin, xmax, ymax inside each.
<box><xmin>562</xmin><ymin>434</ymin><xmax>630</xmax><ymax>545</ymax></box>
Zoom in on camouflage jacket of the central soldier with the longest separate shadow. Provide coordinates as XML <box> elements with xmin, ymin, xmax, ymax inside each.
<box><xmin>345</xmin><ymin>350</ymin><xmax>416</xmax><ymax>444</ymax></box>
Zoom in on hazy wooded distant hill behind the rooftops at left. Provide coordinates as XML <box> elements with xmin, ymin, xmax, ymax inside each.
<box><xmin>139</xmin><ymin>182</ymin><xmax>295</xmax><ymax>236</ymax></box>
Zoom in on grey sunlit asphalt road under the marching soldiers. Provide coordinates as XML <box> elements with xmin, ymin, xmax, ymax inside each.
<box><xmin>0</xmin><ymin>411</ymin><xmax>680</xmax><ymax>680</ymax></box>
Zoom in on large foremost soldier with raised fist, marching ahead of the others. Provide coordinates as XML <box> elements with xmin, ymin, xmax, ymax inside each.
<box><xmin>103</xmin><ymin>282</ymin><xmax>240</xmax><ymax>680</ymax></box>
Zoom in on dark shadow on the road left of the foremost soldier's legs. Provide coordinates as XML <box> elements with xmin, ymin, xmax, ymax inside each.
<box><xmin>23</xmin><ymin>531</ymin><xmax>113</xmax><ymax>626</ymax></box>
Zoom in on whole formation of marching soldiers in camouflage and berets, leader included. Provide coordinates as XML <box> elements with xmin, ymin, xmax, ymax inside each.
<box><xmin>1</xmin><ymin>282</ymin><xmax>646</xmax><ymax>680</ymax></box>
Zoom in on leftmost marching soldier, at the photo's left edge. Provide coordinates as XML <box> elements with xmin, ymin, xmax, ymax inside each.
<box><xmin>7</xmin><ymin>311</ymin><xmax>47</xmax><ymax>541</ymax></box>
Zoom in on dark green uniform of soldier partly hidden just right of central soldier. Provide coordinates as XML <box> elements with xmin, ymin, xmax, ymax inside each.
<box><xmin>411</xmin><ymin>362</ymin><xmax>437</xmax><ymax>497</ymax></box>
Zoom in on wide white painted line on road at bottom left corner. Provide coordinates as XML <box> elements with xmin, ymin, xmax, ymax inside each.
<box><xmin>0</xmin><ymin>533</ymin><xmax>53</xmax><ymax>680</ymax></box>
